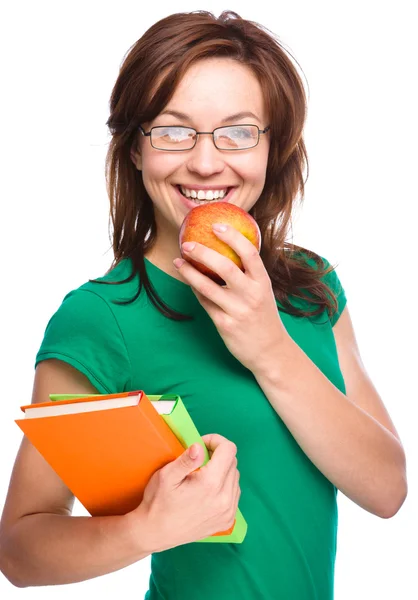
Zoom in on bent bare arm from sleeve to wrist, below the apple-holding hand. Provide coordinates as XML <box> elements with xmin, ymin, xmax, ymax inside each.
<box><xmin>254</xmin><ymin>306</ymin><xmax>407</xmax><ymax>518</ymax></box>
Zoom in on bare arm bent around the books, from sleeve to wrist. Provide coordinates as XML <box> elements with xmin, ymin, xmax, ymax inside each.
<box><xmin>0</xmin><ymin>360</ymin><xmax>152</xmax><ymax>587</ymax></box>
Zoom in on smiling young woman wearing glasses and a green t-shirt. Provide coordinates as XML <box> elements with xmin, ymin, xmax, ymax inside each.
<box><xmin>0</xmin><ymin>12</ymin><xmax>407</xmax><ymax>600</ymax></box>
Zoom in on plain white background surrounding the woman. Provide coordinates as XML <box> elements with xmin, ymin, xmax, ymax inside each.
<box><xmin>0</xmin><ymin>0</ymin><xmax>418</xmax><ymax>600</ymax></box>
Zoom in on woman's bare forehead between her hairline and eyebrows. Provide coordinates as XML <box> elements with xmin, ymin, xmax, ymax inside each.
<box><xmin>158</xmin><ymin>58</ymin><xmax>266</xmax><ymax>126</ymax></box>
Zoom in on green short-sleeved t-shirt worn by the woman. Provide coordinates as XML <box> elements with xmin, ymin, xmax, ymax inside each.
<box><xmin>35</xmin><ymin>254</ymin><xmax>346</xmax><ymax>600</ymax></box>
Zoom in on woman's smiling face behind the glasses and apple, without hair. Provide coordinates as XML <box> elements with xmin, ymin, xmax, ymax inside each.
<box><xmin>131</xmin><ymin>58</ymin><xmax>269</xmax><ymax>273</ymax></box>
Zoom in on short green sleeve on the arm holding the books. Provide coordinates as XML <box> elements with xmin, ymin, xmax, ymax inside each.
<box><xmin>35</xmin><ymin>288</ymin><xmax>131</xmax><ymax>394</ymax></box>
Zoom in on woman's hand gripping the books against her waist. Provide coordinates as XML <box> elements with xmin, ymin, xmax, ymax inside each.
<box><xmin>131</xmin><ymin>433</ymin><xmax>241</xmax><ymax>552</ymax></box>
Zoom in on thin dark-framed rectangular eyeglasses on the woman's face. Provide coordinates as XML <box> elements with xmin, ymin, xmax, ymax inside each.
<box><xmin>139</xmin><ymin>125</ymin><xmax>270</xmax><ymax>152</ymax></box>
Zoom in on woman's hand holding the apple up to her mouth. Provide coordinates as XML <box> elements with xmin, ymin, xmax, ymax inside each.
<box><xmin>174</xmin><ymin>225</ymin><xmax>288</xmax><ymax>373</ymax></box>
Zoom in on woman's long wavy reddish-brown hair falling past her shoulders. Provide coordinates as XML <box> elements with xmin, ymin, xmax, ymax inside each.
<box><xmin>89</xmin><ymin>11</ymin><xmax>338</xmax><ymax>320</ymax></box>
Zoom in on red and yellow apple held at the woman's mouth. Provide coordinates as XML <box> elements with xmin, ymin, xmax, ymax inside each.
<box><xmin>179</xmin><ymin>201</ymin><xmax>261</xmax><ymax>285</ymax></box>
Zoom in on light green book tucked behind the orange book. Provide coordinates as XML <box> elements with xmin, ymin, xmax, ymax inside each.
<box><xmin>49</xmin><ymin>394</ymin><xmax>248</xmax><ymax>544</ymax></box>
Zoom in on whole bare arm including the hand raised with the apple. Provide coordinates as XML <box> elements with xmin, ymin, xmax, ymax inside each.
<box><xmin>169</xmin><ymin>226</ymin><xmax>407</xmax><ymax>518</ymax></box>
